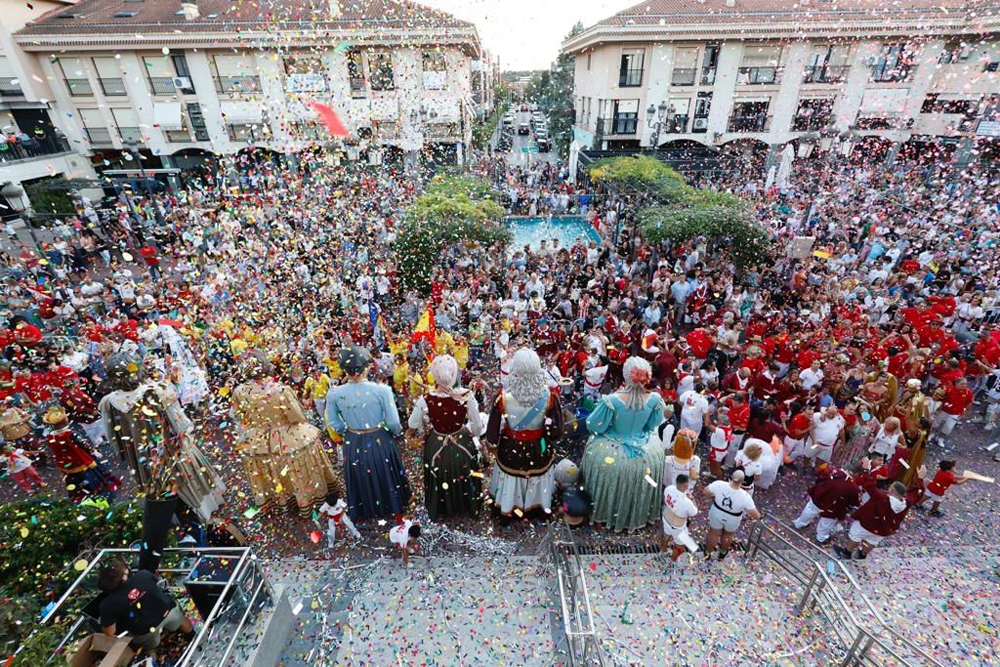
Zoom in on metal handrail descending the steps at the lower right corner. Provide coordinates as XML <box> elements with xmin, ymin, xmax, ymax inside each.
<box><xmin>746</xmin><ymin>519</ymin><xmax>943</xmax><ymax>667</ymax></box>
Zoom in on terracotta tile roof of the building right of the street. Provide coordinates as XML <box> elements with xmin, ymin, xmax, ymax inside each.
<box><xmin>598</xmin><ymin>0</ymin><xmax>1000</xmax><ymax>26</ymax></box>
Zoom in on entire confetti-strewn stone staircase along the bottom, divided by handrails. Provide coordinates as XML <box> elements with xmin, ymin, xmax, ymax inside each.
<box><xmin>271</xmin><ymin>547</ymin><xmax>1000</xmax><ymax>667</ymax></box>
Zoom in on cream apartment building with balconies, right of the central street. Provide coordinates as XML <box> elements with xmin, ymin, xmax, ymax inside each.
<box><xmin>563</xmin><ymin>0</ymin><xmax>1000</xmax><ymax>160</ymax></box>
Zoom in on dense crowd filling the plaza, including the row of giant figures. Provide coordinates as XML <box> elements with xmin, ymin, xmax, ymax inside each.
<box><xmin>0</xmin><ymin>141</ymin><xmax>1000</xmax><ymax>576</ymax></box>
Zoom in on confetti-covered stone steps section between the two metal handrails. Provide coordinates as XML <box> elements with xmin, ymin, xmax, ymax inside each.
<box><xmin>581</xmin><ymin>553</ymin><xmax>836</xmax><ymax>666</ymax></box>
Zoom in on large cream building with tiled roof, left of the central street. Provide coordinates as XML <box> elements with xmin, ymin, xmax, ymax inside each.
<box><xmin>14</xmin><ymin>0</ymin><xmax>492</xmax><ymax>179</ymax></box>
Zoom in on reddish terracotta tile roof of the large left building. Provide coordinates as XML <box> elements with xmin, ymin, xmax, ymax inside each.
<box><xmin>17</xmin><ymin>0</ymin><xmax>474</xmax><ymax>35</ymax></box>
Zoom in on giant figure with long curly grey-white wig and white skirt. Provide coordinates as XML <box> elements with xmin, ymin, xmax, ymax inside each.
<box><xmin>486</xmin><ymin>349</ymin><xmax>563</xmax><ymax>516</ymax></box>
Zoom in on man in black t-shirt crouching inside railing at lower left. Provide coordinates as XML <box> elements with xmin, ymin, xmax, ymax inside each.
<box><xmin>98</xmin><ymin>562</ymin><xmax>194</xmax><ymax>659</ymax></box>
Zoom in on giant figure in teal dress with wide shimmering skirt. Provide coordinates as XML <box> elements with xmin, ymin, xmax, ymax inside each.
<box><xmin>580</xmin><ymin>357</ymin><xmax>665</xmax><ymax>531</ymax></box>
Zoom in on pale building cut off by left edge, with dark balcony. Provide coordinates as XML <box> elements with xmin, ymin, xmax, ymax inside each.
<box><xmin>0</xmin><ymin>0</ymin><xmax>96</xmax><ymax>221</ymax></box>
